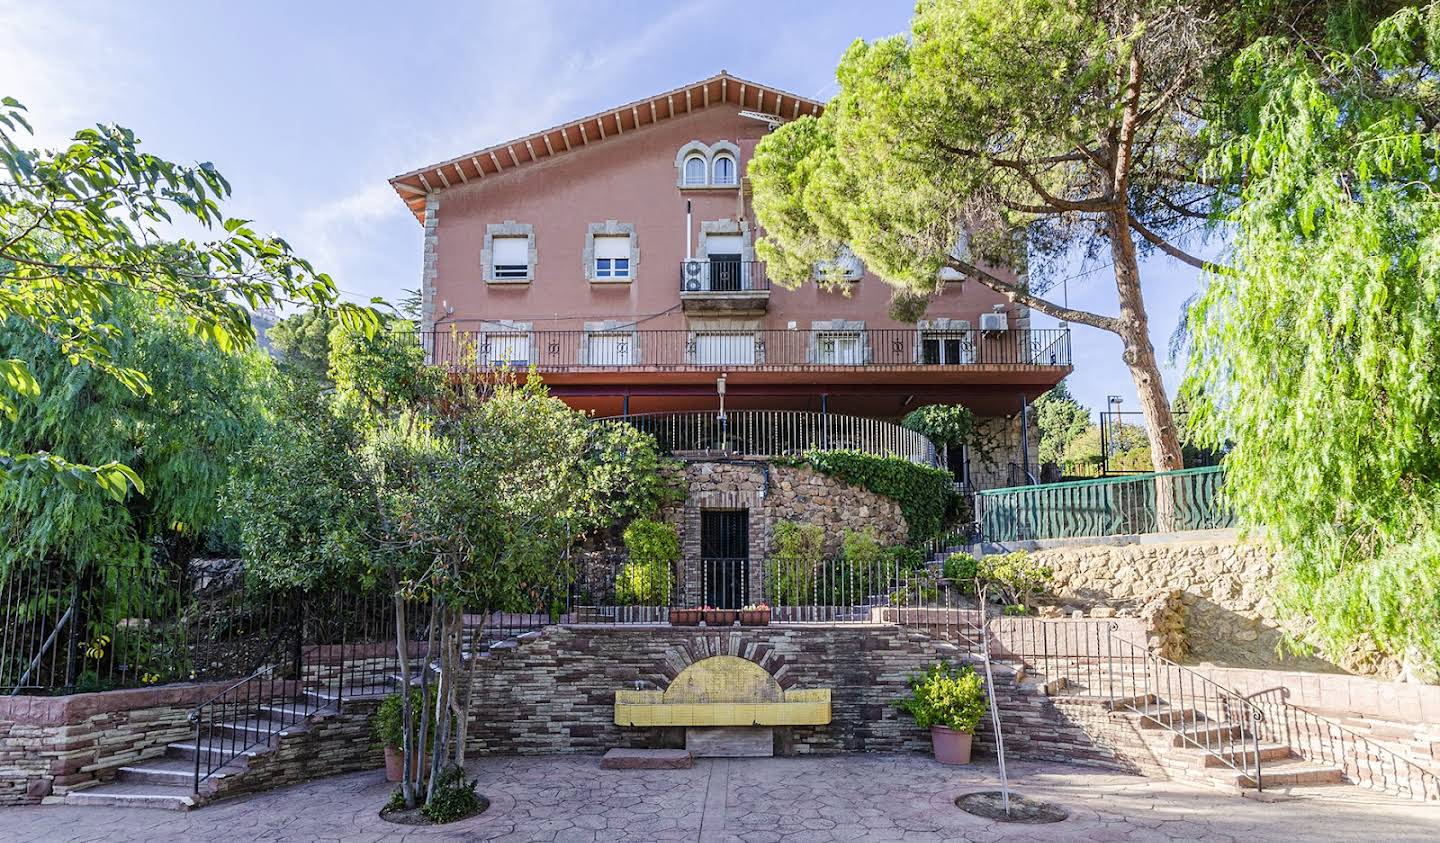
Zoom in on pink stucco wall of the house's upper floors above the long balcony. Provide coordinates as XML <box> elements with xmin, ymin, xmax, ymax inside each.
<box><xmin>435</xmin><ymin>104</ymin><xmax>1015</xmax><ymax>330</ymax></box>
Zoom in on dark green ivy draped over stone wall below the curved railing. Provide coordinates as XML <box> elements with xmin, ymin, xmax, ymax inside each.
<box><xmin>798</xmin><ymin>451</ymin><xmax>958</xmax><ymax>542</ymax></box>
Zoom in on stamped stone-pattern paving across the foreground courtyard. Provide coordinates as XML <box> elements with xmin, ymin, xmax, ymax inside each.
<box><xmin>0</xmin><ymin>755</ymin><xmax>1440</xmax><ymax>843</ymax></box>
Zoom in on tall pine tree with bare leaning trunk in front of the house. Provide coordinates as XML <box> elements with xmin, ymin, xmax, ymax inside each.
<box><xmin>749</xmin><ymin>0</ymin><xmax>1223</xmax><ymax>470</ymax></box>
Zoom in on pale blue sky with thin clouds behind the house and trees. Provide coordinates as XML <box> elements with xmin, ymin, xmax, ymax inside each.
<box><xmin>0</xmin><ymin>0</ymin><xmax>1198</xmax><ymax>409</ymax></box>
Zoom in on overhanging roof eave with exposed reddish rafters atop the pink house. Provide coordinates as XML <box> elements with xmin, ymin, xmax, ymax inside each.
<box><xmin>390</xmin><ymin>71</ymin><xmax>825</xmax><ymax>220</ymax></box>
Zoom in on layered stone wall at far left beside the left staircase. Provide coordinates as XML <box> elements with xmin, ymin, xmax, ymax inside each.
<box><xmin>0</xmin><ymin>683</ymin><xmax>226</xmax><ymax>806</ymax></box>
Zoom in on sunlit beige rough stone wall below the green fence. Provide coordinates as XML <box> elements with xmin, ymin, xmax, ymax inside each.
<box><xmin>1034</xmin><ymin>538</ymin><xmax>1338</xmax><ymax>670</ymax></box>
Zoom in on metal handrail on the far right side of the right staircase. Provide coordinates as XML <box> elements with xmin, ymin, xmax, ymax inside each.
<box><xmin>1246</xmin><ymin>686</ymin><xmax>1440</xmax><ymax>801</ymax></box>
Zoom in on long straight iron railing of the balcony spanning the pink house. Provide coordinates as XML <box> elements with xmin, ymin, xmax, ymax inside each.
<box><xmin>419</xmin><ymin>327</ymin><xmax>1070</xmax><ymax>372</ymax></box>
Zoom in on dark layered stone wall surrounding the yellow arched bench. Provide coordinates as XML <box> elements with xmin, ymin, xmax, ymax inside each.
<box><xmin>469</xmin><ymin>625</ymin><xmax>1128</xmax><ymax>768</ymax></box>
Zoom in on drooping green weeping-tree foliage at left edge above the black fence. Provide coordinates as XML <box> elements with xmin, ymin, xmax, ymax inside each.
<box><xmin>0</xmin><ymin>294</ymin><xmax>274</xmax><ymax>571</ymax></box>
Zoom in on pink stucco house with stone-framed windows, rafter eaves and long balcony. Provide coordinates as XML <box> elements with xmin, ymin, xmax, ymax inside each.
<box><xmin>390</xmin><ymin>72</ymin><xmax>1070</xmax><ymax>487</ymax></box>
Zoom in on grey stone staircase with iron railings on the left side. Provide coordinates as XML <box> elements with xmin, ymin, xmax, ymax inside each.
<box><xmin>65</xmin><ymin>628</ymin><xmax>540</xmax><ymax>811</ymax></box>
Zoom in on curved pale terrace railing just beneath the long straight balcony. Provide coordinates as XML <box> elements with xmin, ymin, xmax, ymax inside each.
<box><xmin>606</xmin><ymin>409</ymin><xmax>939</xmax><ymax>465</ymax></box>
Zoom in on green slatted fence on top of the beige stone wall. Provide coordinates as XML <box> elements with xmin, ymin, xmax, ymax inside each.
<box><xmin>975</xmin><ymin>465</ymin><xmax>1234</xmax><ymax>542</ymax></box>
